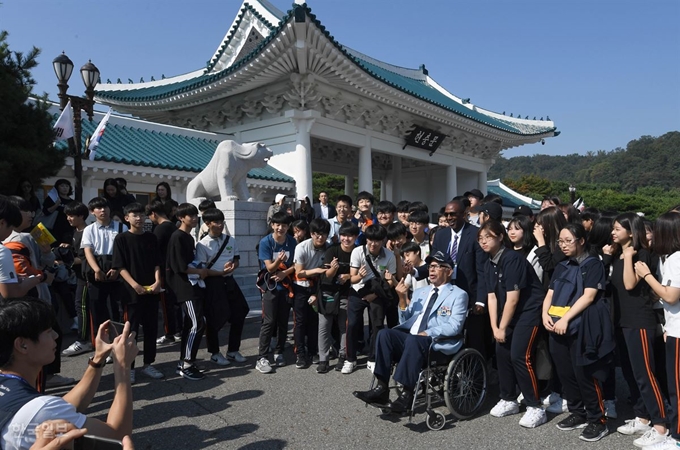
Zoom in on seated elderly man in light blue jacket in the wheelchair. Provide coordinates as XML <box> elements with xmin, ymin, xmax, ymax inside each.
<box><xmin>354</xmin><ymin>252</ymin><xmax>468</xmax><ymax>413</ymax></box>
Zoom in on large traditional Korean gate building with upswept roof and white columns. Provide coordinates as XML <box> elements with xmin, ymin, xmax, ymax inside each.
<box><xmin>95</xmin><ymin>0</ymin><xmax>559</xmax><ymax>210</ymax></box>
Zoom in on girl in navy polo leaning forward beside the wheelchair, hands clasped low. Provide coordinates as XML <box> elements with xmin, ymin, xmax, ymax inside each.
<box><xmin>477</xmin><ymin>220</ymin><xmax>547</xmax><ymax>428</ymax></box>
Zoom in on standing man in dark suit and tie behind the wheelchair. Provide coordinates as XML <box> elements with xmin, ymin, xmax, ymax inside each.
<box><xmin>418</xmin><ymin>200</ymin><xmax>491</xmax><ymax>358</ymax></box>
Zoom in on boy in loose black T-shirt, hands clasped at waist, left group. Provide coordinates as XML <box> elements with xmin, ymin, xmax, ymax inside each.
<box><xmin>113</xmin><ymin>202</ymin><xmax>164</xmax><ymax>384</ymax></box>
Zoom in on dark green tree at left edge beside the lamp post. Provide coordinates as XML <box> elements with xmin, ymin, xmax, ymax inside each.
<box><xmin>0</xmin><ymin>31</ymin><xmax>66</xmax><ymax>194</ymax></box>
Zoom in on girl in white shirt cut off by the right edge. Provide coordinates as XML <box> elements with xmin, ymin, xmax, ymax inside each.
<box><xmin>635</xmin><ymin>212</ymin><xmax>680</xmax><ymax>450</ymax></box>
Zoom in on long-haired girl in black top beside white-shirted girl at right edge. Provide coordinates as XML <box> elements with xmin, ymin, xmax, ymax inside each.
<box><xmin>610</xmin><ymin>213</ymin><xmax>668</xmax><ymax>447</ymax></box>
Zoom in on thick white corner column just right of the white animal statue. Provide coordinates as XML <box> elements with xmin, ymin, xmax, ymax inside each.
<box><xmin>286</xmin><ymin>110</ymin><xmax>318</xmax><ymax>200</ymax></box>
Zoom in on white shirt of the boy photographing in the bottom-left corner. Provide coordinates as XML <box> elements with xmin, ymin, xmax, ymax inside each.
<box><xmin>0</xmin><ymin>395</ymin><xmax>87</xmax><ymax>450</ymax></box>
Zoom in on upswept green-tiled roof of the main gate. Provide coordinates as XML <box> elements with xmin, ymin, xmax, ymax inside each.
<box><xmin>96</xmin><ymin>3</ymin><xmax>559</xmax><ymax>136</ymax></box>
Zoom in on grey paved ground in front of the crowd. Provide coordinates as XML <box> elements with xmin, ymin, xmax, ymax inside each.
<box><xmin>51</xmin><ymin>319</ymin><xmax>635</xmax><ymax>450</ymax></box>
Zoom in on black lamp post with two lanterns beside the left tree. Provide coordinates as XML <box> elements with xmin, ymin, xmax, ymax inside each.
<box><xmin>52</xmin><ymin>52</ymin><xmax>99</xmax><ymax>202</ymax></box>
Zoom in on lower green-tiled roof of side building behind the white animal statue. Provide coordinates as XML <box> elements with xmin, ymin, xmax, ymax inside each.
<box><xmin>67</xmin><ymin>115</ymin><xmax>295</xmax><ymax>183</ymax></box>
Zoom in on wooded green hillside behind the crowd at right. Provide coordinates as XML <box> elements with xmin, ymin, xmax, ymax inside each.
<box><xmin>489</xmin><ymin>131</ymin><xmax>680</xmax><ymax>217</ymax></box>
